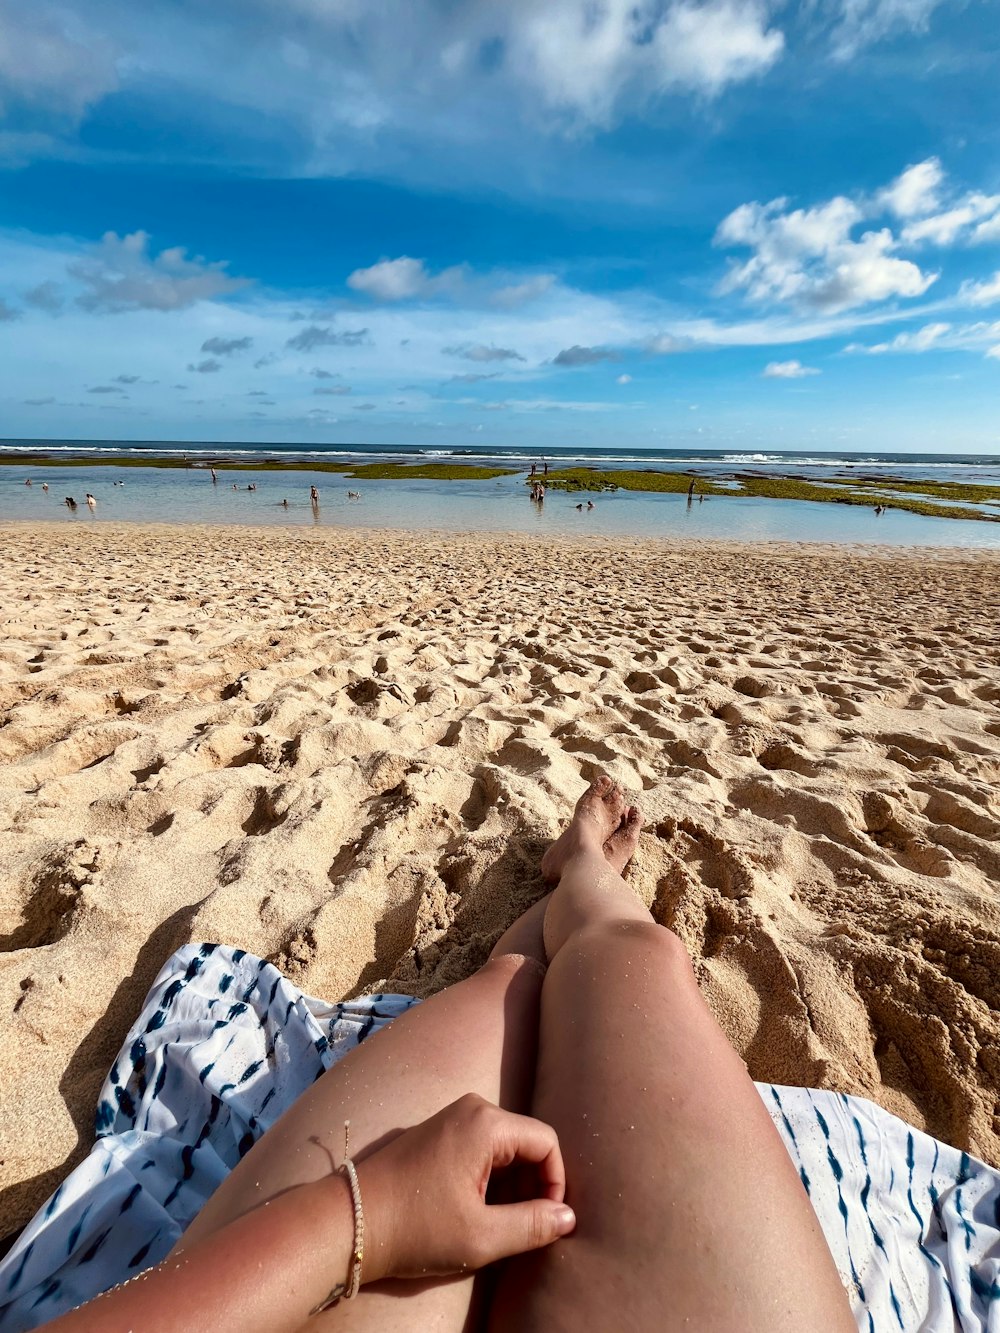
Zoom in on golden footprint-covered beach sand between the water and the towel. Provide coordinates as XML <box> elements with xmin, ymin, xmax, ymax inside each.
<box><xmin>0</xmin><ymin>524</ymin><xmax>1000</xmax><ymax>1236</ymax></box>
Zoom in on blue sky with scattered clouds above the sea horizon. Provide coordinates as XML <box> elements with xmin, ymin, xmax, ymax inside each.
<box><xmin>0</xmin><ymin>0</ymin><xmax>1000</xmax><ymax>453</ymax></box>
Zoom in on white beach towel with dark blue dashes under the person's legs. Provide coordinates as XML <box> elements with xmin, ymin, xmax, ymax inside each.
<box><xmin>0</xmin><ymin>944</ymin><xmax>1000</xmax><ymax>1333</ymax></box>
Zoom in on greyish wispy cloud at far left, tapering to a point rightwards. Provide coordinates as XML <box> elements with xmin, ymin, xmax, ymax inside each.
<box><xmin>68</xmin><ymin>232</ymin><xmax>248</xmax><ymax>312</ymax></box>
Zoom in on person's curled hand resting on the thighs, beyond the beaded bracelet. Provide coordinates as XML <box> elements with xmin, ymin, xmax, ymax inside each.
<box><xmin>357</xmin><ymin>1093</ymin><xmax>576</xmax><ymax>1282</ymax></box>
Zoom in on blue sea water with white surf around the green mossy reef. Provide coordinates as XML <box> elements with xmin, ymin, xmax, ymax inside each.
<box><xmin>0</xmin><ymin>440</ymin><xmax>1000</xmax><ymax>549</ymax></box>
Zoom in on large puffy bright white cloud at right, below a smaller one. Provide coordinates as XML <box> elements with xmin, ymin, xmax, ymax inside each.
<box><xmin>715</xmin><ymin>196</ymin><xmax>937</xmax><ymax>312</ymax></box>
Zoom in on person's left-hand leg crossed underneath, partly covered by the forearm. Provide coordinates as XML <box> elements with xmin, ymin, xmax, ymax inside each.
<box><xmin>182</xmin><ymin>901</ymin><xmax>545</xmax><ymax>1333</ymax></box>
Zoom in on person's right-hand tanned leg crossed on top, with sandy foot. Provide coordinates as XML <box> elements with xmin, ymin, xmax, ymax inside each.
<box><xmin>491</xmin><ymin>778</ymin><xmax>855</xmax><ymax>1333</ymax></box>
